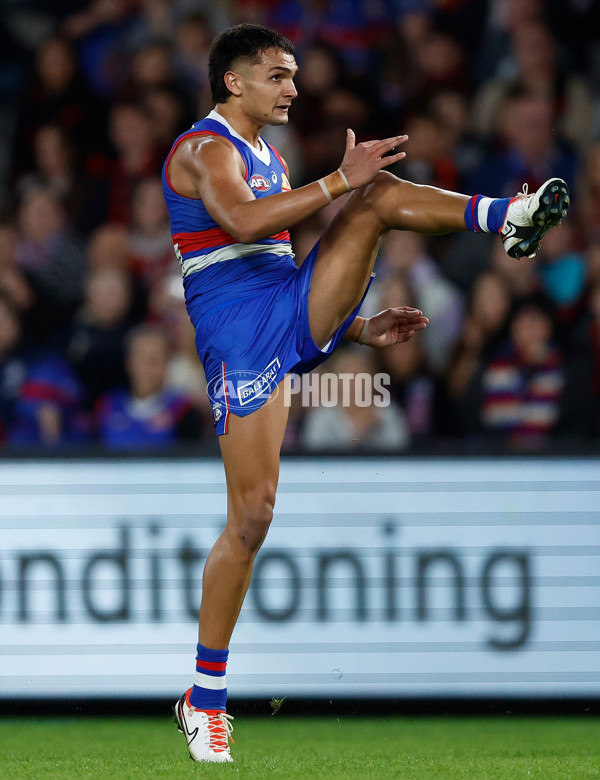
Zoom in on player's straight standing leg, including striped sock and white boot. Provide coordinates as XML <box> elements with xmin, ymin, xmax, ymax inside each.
<box><xmin>175</xmin><ymin>380</ymin><xmax>289</xmax><ymax>763</ymax></box>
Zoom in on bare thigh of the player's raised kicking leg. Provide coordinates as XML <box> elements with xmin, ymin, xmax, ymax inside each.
<box><xmin>308</xmin><ymin>181</ymin><xmax>385</xmax><ymax>346</ymax></box>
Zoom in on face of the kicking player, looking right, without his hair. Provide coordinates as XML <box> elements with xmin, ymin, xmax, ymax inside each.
<box><xmin>240</xmin><ymin>49</ymin><xmax>298</xmax><ymax>125</ymax></box>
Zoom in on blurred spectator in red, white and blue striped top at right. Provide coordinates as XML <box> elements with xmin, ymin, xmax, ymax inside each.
<box><xmin>480</xmin><ymin>300</ymin><xmax>565</xmax><ymax>445</ymax></box>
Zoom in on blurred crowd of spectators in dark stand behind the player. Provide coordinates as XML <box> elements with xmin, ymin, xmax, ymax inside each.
<box><xmin>0</xmin><ymin>0</ymin><xmax>600</xmax><ymax>452</ymax></box>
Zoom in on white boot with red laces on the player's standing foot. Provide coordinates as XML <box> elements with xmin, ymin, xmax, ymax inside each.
<box><xmin>173</xmin><ymin>689</ymin><xmax>233</xmax><ymax>764</ymax></box>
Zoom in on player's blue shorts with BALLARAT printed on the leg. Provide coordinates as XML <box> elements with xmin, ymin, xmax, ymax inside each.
<box><xmin>192</xmin><ymin>243</ymin><xmax>368</xmax><ymax>436</ymax></box>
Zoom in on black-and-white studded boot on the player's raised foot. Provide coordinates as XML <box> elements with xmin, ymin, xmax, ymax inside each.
<box><xmin>500</xmin><ymin>179</ymin><xmax>570</xmax><ymax>258</ymax></box>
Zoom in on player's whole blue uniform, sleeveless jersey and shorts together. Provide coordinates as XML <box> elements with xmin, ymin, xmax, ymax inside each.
<box><xmin>163</xmin><ymin>111</ymin><xmax>366</xmax><ymax>436</ymax></box>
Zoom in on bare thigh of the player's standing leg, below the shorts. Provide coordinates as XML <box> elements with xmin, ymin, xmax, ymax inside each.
<box><xmin>219</xmin><ymin>377</ymin><xmax>289</xmax><ymax>509</ymax></box>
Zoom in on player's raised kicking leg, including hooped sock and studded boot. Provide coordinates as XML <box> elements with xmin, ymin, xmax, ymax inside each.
<box><xmin>309</xmin><ymin>165</ymin><xmax>569</xmax><ymax>346</ymax></box>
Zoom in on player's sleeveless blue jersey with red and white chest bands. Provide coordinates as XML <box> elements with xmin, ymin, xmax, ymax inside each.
<box><xmin>162</xmin><ymin>111</ymin><xmax>296</xmax><ymax>322</ymax></box>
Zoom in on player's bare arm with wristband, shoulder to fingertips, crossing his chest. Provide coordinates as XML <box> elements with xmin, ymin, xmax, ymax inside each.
<box><xmin>169</xmin><ymin>131</ymin><xmax>406</xmax><ymax>244</ymax></box>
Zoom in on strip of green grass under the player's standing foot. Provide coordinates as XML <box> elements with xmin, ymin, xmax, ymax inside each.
<box><xmin>0</xmin><ymin>714</ymin><xmax>600</xmax><ymax>780</ymax></box>
